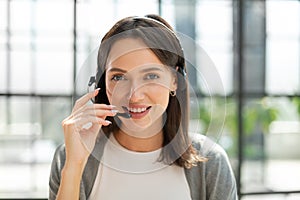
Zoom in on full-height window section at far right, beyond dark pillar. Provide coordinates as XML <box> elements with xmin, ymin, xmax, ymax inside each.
<box><xmin>241</xmin><ymin>0</ymin><xmax>300</xmax><ymax>199</ymax></box>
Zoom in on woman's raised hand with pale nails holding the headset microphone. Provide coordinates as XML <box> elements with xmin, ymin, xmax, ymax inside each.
<box><xmin>62</xmin><ymin>89</ymin><xmax>117</xmax><ymax>167</ymax></box>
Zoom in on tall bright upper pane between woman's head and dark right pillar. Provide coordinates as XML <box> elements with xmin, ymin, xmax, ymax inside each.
<box><xmin>196</xmin><ymin>0</ymin><xmax>233</xmax><ymax>93</ymax></box>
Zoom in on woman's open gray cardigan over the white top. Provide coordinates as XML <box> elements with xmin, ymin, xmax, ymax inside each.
<box><xmin>49</xmin><ymin>134</ymin><xmax>238</xmax><ymax>200</ymax></box>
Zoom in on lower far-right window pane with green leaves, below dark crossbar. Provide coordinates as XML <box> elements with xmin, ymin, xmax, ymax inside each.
<box><xmin>242</xmin><ymin>98</ymin><xmax>300</xmax><ymax>192</ymax></box>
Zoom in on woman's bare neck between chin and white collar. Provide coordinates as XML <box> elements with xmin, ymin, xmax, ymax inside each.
<box><xmin>114</xmin><ymin>129</ymin><xmax>163</xmax><ymax>152</ymax></box>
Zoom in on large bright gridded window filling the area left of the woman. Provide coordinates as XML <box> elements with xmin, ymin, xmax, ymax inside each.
<box><xmin>0</xmin><ymin>0</ymin><xmax>158</xmax><ymax>199</ymax></box>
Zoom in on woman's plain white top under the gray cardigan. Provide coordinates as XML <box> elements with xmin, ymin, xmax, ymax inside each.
<box><xmin>89</xmin><ymin>134</ymin><xmax>191</xmax><ymax>200</ymax></box>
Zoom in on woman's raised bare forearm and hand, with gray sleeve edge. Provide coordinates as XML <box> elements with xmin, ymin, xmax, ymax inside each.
<box><xmin>49</xmin><ymin>90</ymin><xmax>116</xmax><ymax>200</ymax></box>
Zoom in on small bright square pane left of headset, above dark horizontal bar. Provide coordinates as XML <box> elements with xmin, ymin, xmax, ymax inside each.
<box><xmin>35</xmin><ymin>51</ymin><xmax>73</xmax><ymax>94</ymax></box>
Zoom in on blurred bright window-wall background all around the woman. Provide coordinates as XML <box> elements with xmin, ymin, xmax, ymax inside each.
<box><xmin>0</xmin><ymin>0</ymin><xmax>300</xmax><ymax>200</ymax></box>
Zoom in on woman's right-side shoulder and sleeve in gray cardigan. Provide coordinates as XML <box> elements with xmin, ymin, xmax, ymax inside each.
<box><xmin>190</xmin><ymin>134</ymin><xmax>237</xmax><ymax>200</ymax></box>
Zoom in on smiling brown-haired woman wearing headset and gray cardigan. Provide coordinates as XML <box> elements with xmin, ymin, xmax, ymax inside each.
<box><xmin>49</xmin><ymin>15</ymin><xmax>237</xmax><ymax>200</ymax></box>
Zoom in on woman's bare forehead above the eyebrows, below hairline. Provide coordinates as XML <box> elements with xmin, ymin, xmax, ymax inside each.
<box><xmin>106</xmin><ymin>38</ymin><xmax>162</xmax><ymax>71</ymax></box>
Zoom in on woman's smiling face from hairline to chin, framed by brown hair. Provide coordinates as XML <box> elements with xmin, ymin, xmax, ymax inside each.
<box><xmin>105</xmin><ymin>38</ymin><xmax>177</xmax><ymax>137</ymax></box>
